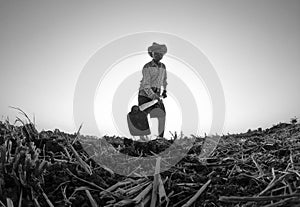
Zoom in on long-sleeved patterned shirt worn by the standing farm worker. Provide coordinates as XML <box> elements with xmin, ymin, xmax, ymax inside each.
<box><xmin>139</xmin><ymin>60</ymin><xmax>168</xmax><ymax>99</ymax></box>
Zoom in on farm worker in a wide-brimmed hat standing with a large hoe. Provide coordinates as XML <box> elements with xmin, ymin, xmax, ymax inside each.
<box><xmin>138</xmin><ymin>42</ymin><xmax>168</xmax><ymax>138</ymax></box>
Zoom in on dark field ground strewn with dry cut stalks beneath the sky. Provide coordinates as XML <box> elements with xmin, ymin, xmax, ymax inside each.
<box><xmin>0</xmin><ymin>110</ymin><xmax>300</xmax><ymax>207</ymax></box>
